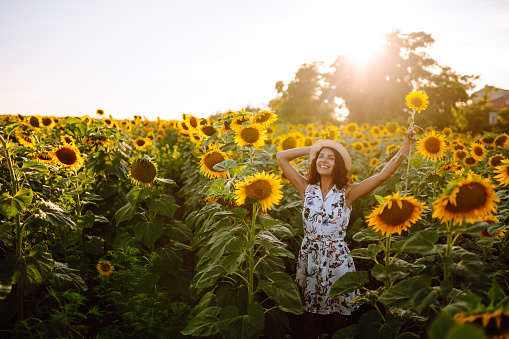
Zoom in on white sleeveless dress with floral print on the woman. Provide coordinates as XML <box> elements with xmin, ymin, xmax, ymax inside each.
<box><xmin>295</xmin><ymin>183</ymin><xmax>359</xmax><ymax>315</ymax></box>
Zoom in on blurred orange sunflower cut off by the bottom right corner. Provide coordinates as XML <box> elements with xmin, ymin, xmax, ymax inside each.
<box><xmin>454</xmin><ymin>309</ymin><xmax>509</xmax><ymax>339</ymax></box>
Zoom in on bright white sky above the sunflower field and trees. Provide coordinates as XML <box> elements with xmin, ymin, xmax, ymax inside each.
<box><xmin>0</xmin><ymin>0</ymin><xmax>509</xmax><ymax>120</ymax></box>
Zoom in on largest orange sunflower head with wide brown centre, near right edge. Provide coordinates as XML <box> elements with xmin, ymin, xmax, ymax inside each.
<box><xmin>432</xmin><ymin>174</ymin><xmax>500</xmax><ymax>226</ymax></box>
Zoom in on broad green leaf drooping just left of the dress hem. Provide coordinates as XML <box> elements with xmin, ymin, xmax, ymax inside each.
<box><xmin>258</xmin><ymin>272</ymin><xmax>303</xmax><ymax>314</ymax></box>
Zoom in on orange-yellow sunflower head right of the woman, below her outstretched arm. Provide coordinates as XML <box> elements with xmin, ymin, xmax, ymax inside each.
<box><xmin>366</xmin><ymin>192</ymin><xmax>426</xmax><ymax>237</ymax></box>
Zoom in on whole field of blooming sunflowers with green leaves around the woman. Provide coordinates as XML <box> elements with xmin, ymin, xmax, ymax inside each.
<box><xmin>0</xmin><ymin>102</ymin><xmax>509</xmax><ymax>339</ymax></box>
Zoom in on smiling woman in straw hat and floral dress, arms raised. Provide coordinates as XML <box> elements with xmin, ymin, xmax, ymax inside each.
<box><xmin>276</xmin><ymin>128</ymin><xmax>415</xmax><ymax>339</ymax></box>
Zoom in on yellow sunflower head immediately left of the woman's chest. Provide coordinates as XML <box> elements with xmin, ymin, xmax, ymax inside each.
<box><xmin>235</xmin><ymin>171</ymin><xmax>283</xmax><ymax>212</ymax></box>
